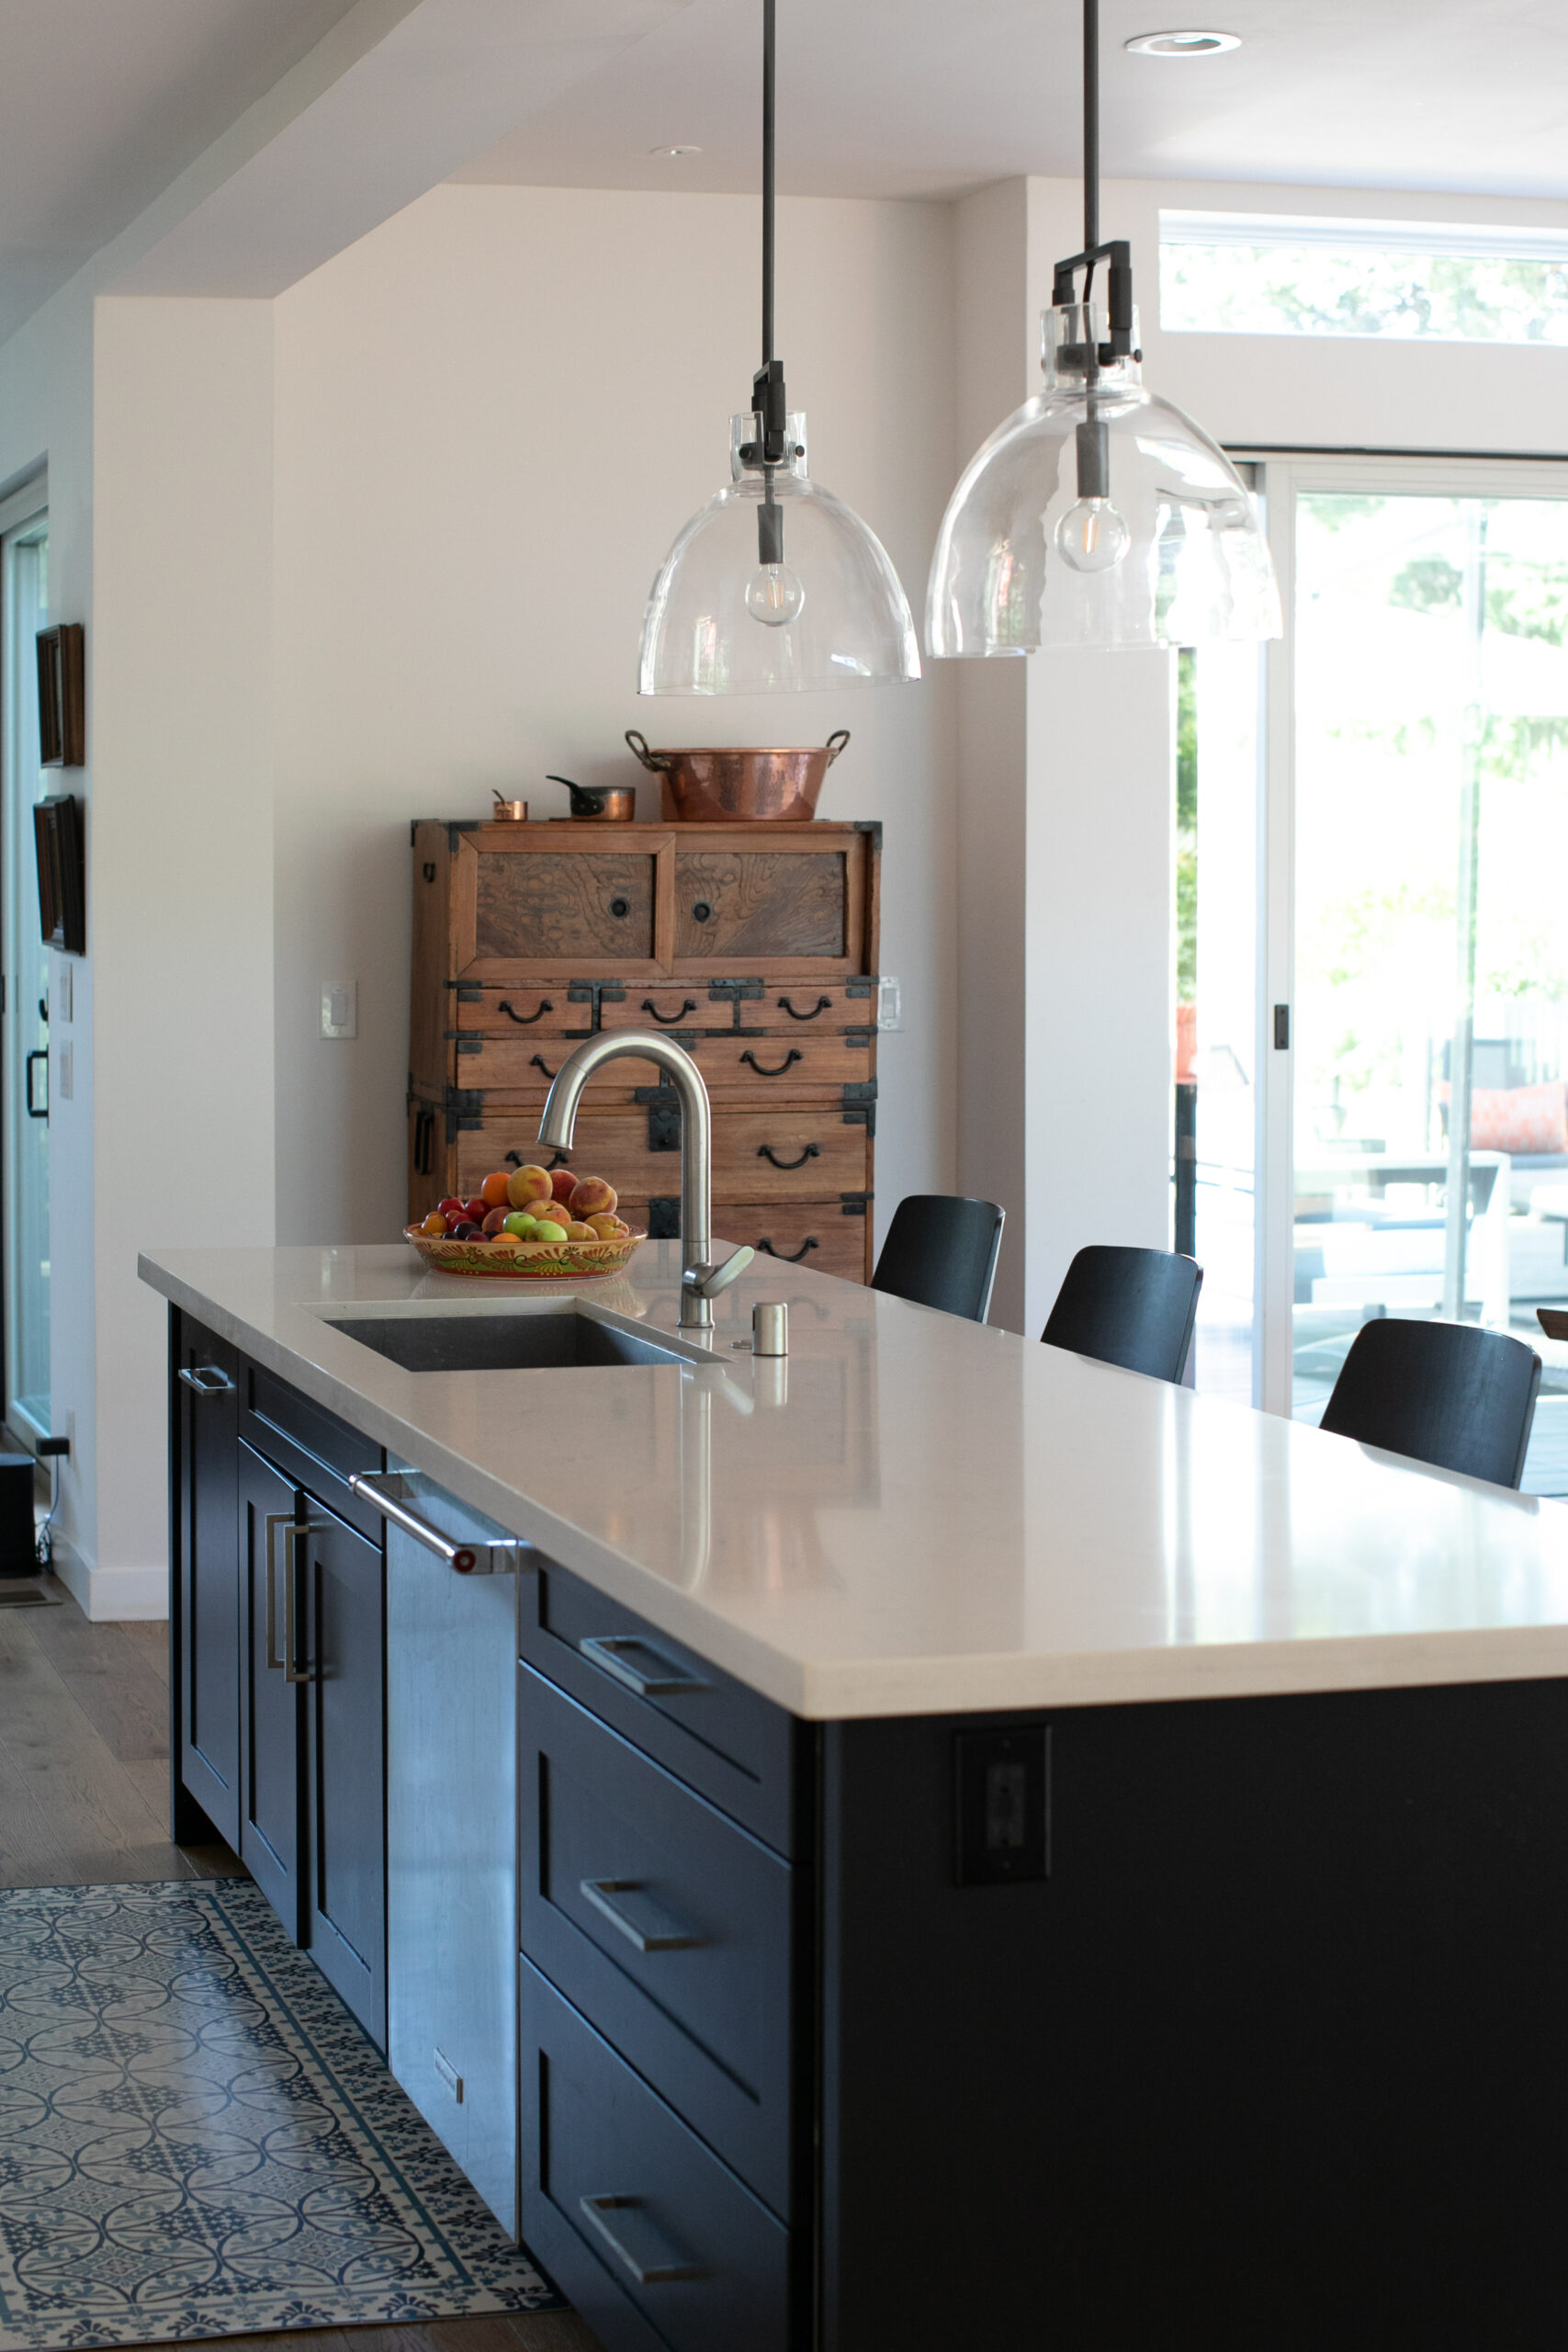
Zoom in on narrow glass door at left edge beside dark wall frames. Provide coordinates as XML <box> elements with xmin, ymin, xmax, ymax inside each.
<box><xmin>0</xmin><ymin>505</ymin><xmax>50</xmax><ymax>1440</ymax></box>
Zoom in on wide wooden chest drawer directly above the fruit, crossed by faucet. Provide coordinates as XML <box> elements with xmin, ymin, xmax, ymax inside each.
<box><xmin>456</xmin><ymin>1103</ymin><xmax>870</xmax><ymax>1202</ymax></box>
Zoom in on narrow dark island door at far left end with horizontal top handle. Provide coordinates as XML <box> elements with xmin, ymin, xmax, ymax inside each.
<box><xmin>174</xmin><ymin>1317</ymin><xmax>240</xmax><ymax>1847</ymax></box>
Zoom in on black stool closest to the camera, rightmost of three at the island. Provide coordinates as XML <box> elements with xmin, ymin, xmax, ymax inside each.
<box><xmin>1319</xmin><ymin>1315</ymin><xmax>1540</xmax><ymax>1487</ymax></box>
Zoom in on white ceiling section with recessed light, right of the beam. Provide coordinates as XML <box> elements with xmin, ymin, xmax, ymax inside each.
<box><xmin>444</xmin><ymin>0</ymin><xmax>1568</xmax><ymax>198</ymax></box>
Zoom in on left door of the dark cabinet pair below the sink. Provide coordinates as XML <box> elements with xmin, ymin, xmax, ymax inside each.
<box><xmin>237</xmin><ymin>1440</ymin><xmax>306</xmax><ymax>1943</ymax></box>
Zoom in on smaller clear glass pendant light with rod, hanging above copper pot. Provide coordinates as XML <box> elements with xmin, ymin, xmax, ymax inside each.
<box><xmin>637</xmin><ymin>0</ymin><xmax>919</xmax><ymax>694</ymax></box>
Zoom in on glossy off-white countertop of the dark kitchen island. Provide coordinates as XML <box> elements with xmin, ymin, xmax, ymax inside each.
<box><xmin>141</xmin><ymin>1242</ymin><xmax>1568</xmax><ymax>1719</ymax></box>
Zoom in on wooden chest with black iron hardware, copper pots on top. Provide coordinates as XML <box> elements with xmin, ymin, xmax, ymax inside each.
<box><xmin>409</xmin><ymin>819</ymin><xmax>882</xmax><ymax>1282</ymax></box>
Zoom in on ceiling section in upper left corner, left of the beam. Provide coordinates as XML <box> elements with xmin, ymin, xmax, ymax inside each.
<box><xmin>0</xmin><ymin>0</ymin><xmax>367</xmax><ymax>341</ymax></box>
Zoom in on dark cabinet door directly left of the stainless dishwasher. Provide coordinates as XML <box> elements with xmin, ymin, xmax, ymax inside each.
<box><xmin>303</xmin><ymin>1500</ymin><xmax>386</xmax><ymax>2049</ymax></box>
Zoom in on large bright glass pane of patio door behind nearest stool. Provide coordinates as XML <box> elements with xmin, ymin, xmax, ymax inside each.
<box><xmin>1291</xmin><ymin>487</ymin><xmax>1568</xmax><ymax>1494</ymax></box>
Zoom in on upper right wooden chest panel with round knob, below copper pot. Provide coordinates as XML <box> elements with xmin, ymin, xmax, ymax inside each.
<box><xmin>672</xmin><ymin>832</ymin><xmax>865</xmax><ymax>971</ymax></box>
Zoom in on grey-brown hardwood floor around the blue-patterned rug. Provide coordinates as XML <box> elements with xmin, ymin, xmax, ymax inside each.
<box><xmin>0</xmin><ymin>1583</ymin><xmax>602</xmax><ymax>2352</ymax></box>
